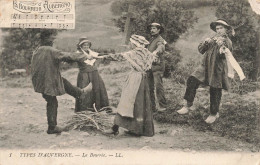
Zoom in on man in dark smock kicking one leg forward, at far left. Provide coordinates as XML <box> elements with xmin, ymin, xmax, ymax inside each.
<box><xmin>31</xmin><ymin>33</ymin><xmax>92</xmax><ymax>134</ymax></box>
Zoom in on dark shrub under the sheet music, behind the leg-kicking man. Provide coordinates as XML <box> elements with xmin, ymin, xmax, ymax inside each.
<box><xmin>0</xmin><ymin>28</ymin><xmax>58</xmax><ymax>72</ymax></box>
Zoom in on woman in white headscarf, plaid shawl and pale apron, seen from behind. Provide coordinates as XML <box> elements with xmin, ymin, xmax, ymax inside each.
<box><xmin>102</xmin><ymin>35</ymin><xmax>156</xmax><ymax>136</ymax></box>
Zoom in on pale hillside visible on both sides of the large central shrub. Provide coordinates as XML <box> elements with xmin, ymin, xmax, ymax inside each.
<box><xmin>55</xmin><ymin>0</ymin><xmax>216</xmax><ymax>63</ymax></box>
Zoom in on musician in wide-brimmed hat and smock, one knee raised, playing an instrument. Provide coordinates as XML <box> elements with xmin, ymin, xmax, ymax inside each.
<box><xmin>177</xmin><ymin>19</ymin><xmax>235</xmax><ymax>124</ymax></box>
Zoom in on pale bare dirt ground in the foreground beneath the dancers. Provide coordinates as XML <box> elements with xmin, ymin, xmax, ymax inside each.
<box><xmin>0</xmin><ymin>88</ymin><xmax>254</xmax><ymax>152</ymax></box>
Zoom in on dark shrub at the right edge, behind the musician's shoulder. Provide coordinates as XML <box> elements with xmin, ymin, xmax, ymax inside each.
<box><xmin>216</xmin><ymin>0</ymin><xmax>260</xmax><ymax>80</ymax></box>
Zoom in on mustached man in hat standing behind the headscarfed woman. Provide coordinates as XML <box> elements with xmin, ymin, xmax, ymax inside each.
<box><xmin>147</xmin><ymin>23</ymin><xmax>166</xmax><ymax>111</ymax></box>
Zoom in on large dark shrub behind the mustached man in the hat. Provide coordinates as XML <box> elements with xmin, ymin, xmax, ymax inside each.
<box><xmin>111</xmin><ymin>0</ymin><xmax>198</xmax><ymax>77</ymax></box>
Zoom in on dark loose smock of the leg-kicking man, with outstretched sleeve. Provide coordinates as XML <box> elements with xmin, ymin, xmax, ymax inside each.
<box><xmin>31</xmin><ymin>46</ymin><xmax>87</xmax><ymax>96</ymax></box>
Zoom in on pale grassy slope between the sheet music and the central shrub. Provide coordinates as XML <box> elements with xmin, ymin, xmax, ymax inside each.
<box><xmin>55</xmin><ymin>0</ymin><xmax>123</xmax><ymax>51</ymax></box>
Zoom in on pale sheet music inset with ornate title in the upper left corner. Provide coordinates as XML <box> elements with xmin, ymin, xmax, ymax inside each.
<box><xmin>0</xmin><ymin>0</ymin><xmax>75</xmax><ymax>29</ymax></box>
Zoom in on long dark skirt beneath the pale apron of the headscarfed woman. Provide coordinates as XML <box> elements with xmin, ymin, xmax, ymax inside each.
<box><xmin>114</xmin><ymin>76</ymin><xmax>154</xmax><ymax>136</ymax></box>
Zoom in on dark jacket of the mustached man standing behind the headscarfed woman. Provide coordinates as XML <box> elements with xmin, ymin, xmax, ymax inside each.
<box><xmin>147</xmin><ymin>35</ymin><xmax>165</xmax><ymax>72</ymax></box>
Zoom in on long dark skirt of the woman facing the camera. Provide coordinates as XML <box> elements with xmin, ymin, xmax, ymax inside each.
<box><xmin>75</xmin><ymin>70</ymin><xmax>109</xmax><ymax>112</ymax></box>
